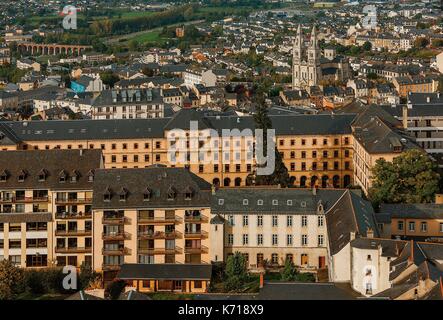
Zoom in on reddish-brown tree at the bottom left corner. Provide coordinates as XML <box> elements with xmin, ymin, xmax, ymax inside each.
<box><xmin>0</xmin><ymin>260</ymin><xmax>23</xmax><ymax>300</ymax></box>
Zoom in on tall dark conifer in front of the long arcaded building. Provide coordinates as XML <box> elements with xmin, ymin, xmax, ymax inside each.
<box><xmin>246</xmin><ymin>92</ymin><xmax>291</xmax><ymax>188</ymax></box>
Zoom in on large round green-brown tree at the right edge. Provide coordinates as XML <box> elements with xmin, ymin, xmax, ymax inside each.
<box><xmin>369</xmin><ymin>149</ymin><xmax>440</xmax><ymax>205</ymax></box>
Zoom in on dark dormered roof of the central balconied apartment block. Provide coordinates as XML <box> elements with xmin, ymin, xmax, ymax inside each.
<box><xmin>93</xmin><ymin>167</ymin><xmax>211</xmax><ymax>209</ymax></box>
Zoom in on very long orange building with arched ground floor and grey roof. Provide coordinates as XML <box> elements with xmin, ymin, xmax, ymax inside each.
<box><xmin>0</xmin><ymin>109</ymin><xmax>355</xmax><ymax>188</ymax></box>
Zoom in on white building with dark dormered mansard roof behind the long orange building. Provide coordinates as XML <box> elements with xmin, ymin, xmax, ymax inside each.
<box><xmin>91</xmin><ymin>89</ymin><xmax>164</xmax><ymax>119</ymax></box>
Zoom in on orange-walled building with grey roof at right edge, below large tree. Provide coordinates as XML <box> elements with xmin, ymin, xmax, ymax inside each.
<box><xmin>380</xmin><ymin>203</ymin><xmax>443</xmax><ymax>241</ymax></box>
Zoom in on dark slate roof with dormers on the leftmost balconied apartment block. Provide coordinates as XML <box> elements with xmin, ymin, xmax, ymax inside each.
<box><xmin>0</xmin><ymin>149</ymin><xmax>103</xmax><ymax>190</ymax></box>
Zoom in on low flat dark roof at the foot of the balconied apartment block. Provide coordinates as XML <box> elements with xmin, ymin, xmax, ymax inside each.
<box><xmin>117</xmin><ymin>263</ymin><xmax>212</xmax><ymax>280</ymax></box>
